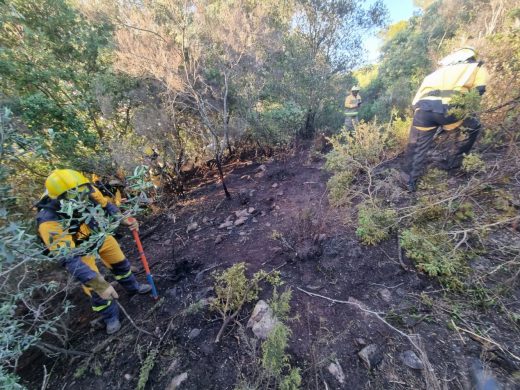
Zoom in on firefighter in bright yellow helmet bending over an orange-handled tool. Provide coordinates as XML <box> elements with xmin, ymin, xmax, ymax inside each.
<box><xmin>36</xmin><ymin>169</ymin><xmax>151</xmax><ymax>334</ymax></box>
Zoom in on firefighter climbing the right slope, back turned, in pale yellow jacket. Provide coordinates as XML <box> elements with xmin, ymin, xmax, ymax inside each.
<box><xmin>407</xmin><ymin>48</ymin><xmax>489</xmax><ymax>191</ymax></box>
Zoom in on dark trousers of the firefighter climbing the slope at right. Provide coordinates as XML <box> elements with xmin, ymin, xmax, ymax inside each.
<box><xmin>407</xmin><ymin>110</ymin><xmax>481</xmax><ymax>183</ymax></box>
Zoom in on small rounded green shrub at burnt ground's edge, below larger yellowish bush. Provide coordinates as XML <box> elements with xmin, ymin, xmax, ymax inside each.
<box><xmin>356</xmin><ymin>202</ymin><xmax>397</xmax><ymax>245</ymax></box>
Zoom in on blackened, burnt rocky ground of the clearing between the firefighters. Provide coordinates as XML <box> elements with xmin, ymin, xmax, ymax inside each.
<box><xmin>21</xmin><ymin>150</ymin><xmax>520</xmax><ymax>389</ymax></box>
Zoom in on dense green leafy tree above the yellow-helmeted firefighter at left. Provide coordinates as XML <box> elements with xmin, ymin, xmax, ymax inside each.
<box><xmin>0</xmin><ymin>0</ymin><xmax>112</xmax><ymax>172</ymax></box>
